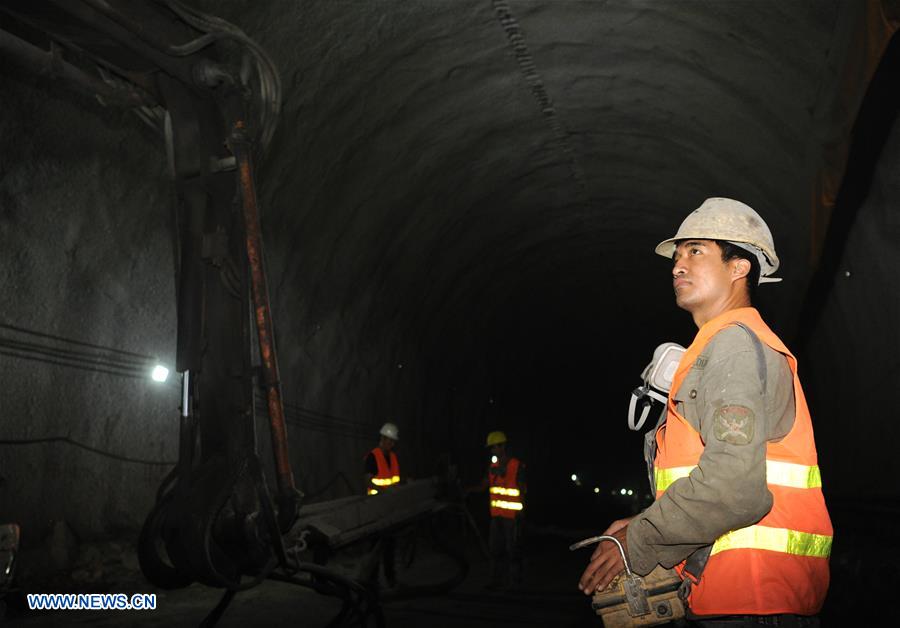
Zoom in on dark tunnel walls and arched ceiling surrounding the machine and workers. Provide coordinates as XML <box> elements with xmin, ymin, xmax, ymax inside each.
<box><xmin>0</xmin><ymin>0</ymin><xmax>900</xmax><ymax>626</ymax></box>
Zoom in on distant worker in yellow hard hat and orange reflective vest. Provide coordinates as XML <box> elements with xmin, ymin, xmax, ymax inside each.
<box><xmin>472</xmin><ymin>431</ymin><xmax>525</xmax><ymax>589</ymax></box>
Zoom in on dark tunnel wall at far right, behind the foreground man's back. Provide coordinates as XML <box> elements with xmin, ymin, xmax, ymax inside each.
<box><xmin>801</xmin><ymin>108</ymin><xmax>900</xmax><ymax>504</ymax></box>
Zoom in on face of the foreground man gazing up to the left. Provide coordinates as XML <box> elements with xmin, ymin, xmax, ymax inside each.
<box><xmin>672</xmin><ymin>240</ymin><xmax>735</xmax><ymax>312</ymax></box>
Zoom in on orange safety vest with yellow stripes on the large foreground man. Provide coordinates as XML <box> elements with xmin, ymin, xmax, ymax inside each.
<box><xmin>655</xmin><ymin>308</ymin><xmax>833</xmax><ymax>615</ymax></box>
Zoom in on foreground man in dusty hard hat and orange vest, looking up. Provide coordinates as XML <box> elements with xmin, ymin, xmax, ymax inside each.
<box><xmin>579</xmin><ymin>198</ymin><xmax>832</xmax><ymax>627</ymax></box>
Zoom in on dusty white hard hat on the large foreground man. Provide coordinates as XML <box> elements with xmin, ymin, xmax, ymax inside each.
<box><xmin>656</xmin><ymin>197</ymin><xmax>781</xmax><ymax>283</ymax></box>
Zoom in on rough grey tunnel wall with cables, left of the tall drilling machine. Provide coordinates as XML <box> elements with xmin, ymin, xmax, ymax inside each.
<box><xmin>0</xmin><ymin>74</ymin><xmax>179</xmax><ymax>544</ymax></box>
